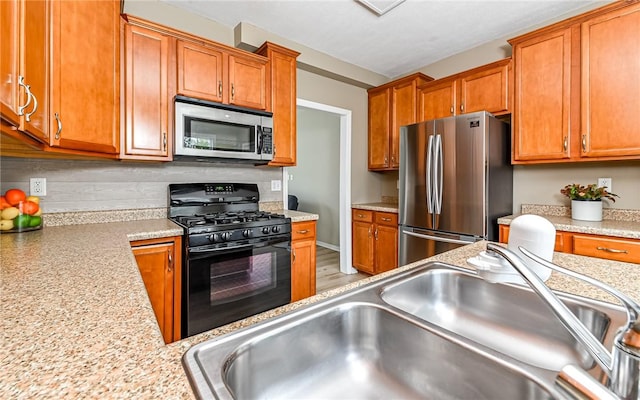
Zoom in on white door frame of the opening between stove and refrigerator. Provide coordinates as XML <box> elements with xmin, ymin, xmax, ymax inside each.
<box><xmin>282</xmin><ymin>98</ymin><xmax>358</xmax><ymax>274</ymax></box>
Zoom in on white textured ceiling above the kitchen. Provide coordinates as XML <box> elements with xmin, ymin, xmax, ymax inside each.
<box><xmin>162</xmin><ymin>0</ymin><xmax>608</xmax><ymax>78</ymax></box>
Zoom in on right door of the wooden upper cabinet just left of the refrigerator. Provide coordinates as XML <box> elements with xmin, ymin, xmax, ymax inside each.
<box><xmin>389</xmin><ymin>81</ymin><xmax>417</xmax><ymax>168</ymax></box>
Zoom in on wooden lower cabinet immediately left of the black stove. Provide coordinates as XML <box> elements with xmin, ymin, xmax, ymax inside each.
<box><xmin>131</xmin><ymin>236</ymin><xmax>182</xmax><ymax>343</ymax></box>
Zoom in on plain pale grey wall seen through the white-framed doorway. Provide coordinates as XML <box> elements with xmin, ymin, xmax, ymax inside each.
<box><xmin>288</xmin><ymin>107</ymin><xmax>340</xmax><ymax>247</ymax></box>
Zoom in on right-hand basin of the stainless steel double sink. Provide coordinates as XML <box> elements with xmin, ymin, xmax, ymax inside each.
<box><xmin>381</xmin><ymin>268</ymin><xmax>620</xmax><ymax>371</ymax></box>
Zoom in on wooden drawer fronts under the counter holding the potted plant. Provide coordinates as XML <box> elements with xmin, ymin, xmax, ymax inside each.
<box><xmin>500</xmin><ymin>225</ymin><xmax>640</xmax><ymax>264</ymax></box>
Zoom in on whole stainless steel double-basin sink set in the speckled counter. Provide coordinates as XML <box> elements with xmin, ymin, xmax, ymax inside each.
<box><xmin>183</xmin><ymin>262</ymin><xmax>626</xmax><ymax>399</ymax></box>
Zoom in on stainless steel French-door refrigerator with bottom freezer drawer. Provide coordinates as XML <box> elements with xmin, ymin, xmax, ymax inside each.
<box><xmin>398</xmin><ymin>111</ymin><xmax>513</xmax><ymax>265</ymax></box>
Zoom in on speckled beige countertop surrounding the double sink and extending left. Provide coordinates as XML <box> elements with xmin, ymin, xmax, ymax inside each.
<box><xmin>0</xmin><ymin>219</ymin><xmax>640</xmax><ymax>399</ymax></box>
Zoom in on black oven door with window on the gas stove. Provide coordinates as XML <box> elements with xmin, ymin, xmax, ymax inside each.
<box><xmin>182</xmin><ymin>234</ymin><xmax>291</xmax><ymax>337</ymax></box>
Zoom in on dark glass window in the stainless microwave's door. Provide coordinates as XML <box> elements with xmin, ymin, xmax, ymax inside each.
<box><xmin>184</xmin><ymin>116</ymin><xmax>257</xmax><ymax>153</ymax></box>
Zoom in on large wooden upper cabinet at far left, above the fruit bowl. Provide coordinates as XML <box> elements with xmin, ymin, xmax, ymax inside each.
<box><xmin>0</xmin><ymin>0</ymin><xmax>120</xmax><ymax>158</ymax></box>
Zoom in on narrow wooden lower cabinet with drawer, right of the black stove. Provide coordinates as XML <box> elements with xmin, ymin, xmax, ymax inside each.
<box><xmin>291</xmin><ymin>221</ymin><xmax>316</xmax><ymax>302</ymax></box>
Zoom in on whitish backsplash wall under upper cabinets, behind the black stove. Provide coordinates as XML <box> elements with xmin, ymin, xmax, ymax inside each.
<box><xmin>0</xmin><ymin>157</ymin><xmax>282</xmax><ymax>213</ymax></box>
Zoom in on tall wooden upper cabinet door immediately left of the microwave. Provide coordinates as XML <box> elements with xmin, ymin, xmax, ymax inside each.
<box><xmin>120</xmin><ymin>24</ymin><xmax>173</xmax><ymax>161</ymax></box>
